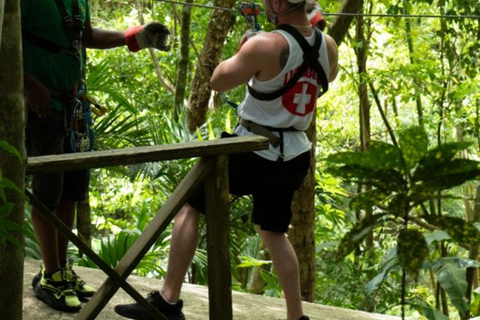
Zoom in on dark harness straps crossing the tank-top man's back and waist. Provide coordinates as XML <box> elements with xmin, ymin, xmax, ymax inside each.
<box><xmin>239</xmin><ymin>24</ymin><xmax>328</xmax><ymax>161</ymax></box>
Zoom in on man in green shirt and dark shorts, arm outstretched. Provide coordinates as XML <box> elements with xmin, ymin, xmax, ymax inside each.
<box><xmin>21</xmin><ymin>0</ymin><xmax>169</xmax><ymax>312</ymax></box>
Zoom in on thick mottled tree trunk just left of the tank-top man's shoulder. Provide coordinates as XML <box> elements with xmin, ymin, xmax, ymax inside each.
<box><xmin>188</xmin><ymin>0</ymin><xmax>235</xmax><ymax>133</ymax></box>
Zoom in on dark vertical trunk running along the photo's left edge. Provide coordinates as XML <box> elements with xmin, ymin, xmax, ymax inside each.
<box><xmin>0</xmin><ymin>0</ymin><xmax>25</xmax><ymax>320</ymax></box>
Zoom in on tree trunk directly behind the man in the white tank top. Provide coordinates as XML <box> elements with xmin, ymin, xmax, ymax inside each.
<box><xmin>289</xmin><ymin>0</ymin><xmax>363</xmax><ymax>302</ymax></box>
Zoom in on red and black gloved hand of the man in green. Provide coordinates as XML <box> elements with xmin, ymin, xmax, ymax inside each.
<box><xmin>125</xmin><ymin>22</ymin><xmax>170</xmax><ymax>52</ymax></box>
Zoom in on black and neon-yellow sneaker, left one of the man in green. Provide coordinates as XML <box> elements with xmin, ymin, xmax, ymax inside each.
<box><xmin>32</xmin><ymin>271</ymin><xmax>82</xmax><ymax>312</ymax></box>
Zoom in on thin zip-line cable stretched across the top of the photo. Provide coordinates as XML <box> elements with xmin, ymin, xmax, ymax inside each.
<box><xmin>157</xmin><ymin>0</ymin><xmax>480</xmax><ymax>19</ymax></box>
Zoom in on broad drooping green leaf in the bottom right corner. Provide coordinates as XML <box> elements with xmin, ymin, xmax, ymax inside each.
<box><xmin>432</xmin><ymin>259</ymin><xmax>468</xmax><ymax>313</ymax></box>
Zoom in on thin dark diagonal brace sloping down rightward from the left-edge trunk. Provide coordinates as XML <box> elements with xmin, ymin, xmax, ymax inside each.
<box><xmin>25</xmin><ymin>190</ymin><xmax>168</xmax><ymax>320</ymax></box>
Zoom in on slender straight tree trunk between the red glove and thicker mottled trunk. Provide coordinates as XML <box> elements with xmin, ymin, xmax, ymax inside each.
<box><xmin>174</xmin><ymin>0</ymin><xmax>193</xmax><ymax>121</ymax></box>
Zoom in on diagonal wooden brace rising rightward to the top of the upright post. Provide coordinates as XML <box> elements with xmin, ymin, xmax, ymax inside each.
<box><xmin>76</xmin><ymin>158</ymin><xmax>213</xmax><ymax>320</ymax></box>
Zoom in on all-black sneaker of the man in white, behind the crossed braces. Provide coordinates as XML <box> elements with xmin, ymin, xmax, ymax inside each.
<box><xmin>115</xmin><ymin>291</ymin><xmax>185</xmax><ymax>320</ymax></box>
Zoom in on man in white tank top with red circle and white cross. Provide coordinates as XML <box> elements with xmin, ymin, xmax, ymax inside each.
<box><xmin>211</xmin><ymin>0</ymin><xmax>338</xmax><ymax>320</ymax></box>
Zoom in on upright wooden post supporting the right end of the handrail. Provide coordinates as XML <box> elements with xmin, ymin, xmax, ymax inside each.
<box><xmin>205</xmin><ymin>156</ymin><xmax>233</xmax><ymax>320</ymax></box>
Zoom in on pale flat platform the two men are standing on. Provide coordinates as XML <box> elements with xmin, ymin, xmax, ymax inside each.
<box><xmin>23</xmin><ymin>260</ymin><xmax>400</xmax><ymax>320</ymax></box>
